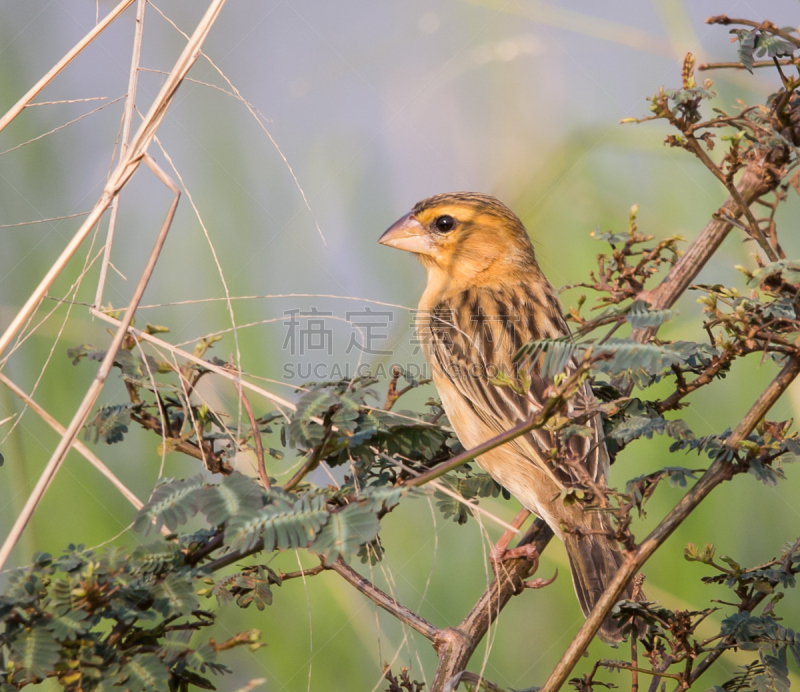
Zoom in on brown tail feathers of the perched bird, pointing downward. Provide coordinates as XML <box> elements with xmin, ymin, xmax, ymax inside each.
<box><xmin>564</xmin><ymin>513</ymin><xmax>643</xmax><ymax>643</ymax></box>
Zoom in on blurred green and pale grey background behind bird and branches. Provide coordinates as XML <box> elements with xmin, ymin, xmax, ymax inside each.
<box><xmin>0</xmin><ymin>0</ymin><xmax>800</xmax><ymax>690</ymax></box>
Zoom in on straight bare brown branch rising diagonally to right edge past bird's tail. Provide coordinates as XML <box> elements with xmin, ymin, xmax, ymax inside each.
<box><xmin>541</xmin><ymin>358</ymin><xmax>800</xmax><ymax>692</ymax></box>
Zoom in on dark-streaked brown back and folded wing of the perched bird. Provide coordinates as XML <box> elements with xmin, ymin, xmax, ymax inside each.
<box><xmin>425</xmin><ymin>286</ymin><xmax>608</xmax><ymax>487</ymax></box>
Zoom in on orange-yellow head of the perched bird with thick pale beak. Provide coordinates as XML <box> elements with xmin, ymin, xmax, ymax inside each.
<box><xmin>378</xmin><ymin>192</ymin><xmax>535</xmax><ymax>289</ymax></box>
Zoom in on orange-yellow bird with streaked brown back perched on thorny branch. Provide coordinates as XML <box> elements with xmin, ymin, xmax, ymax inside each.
<box><xmin>379</xmin><ymin>192</ymin><xmax>631</xmax><ymax>641</ymax></box>
